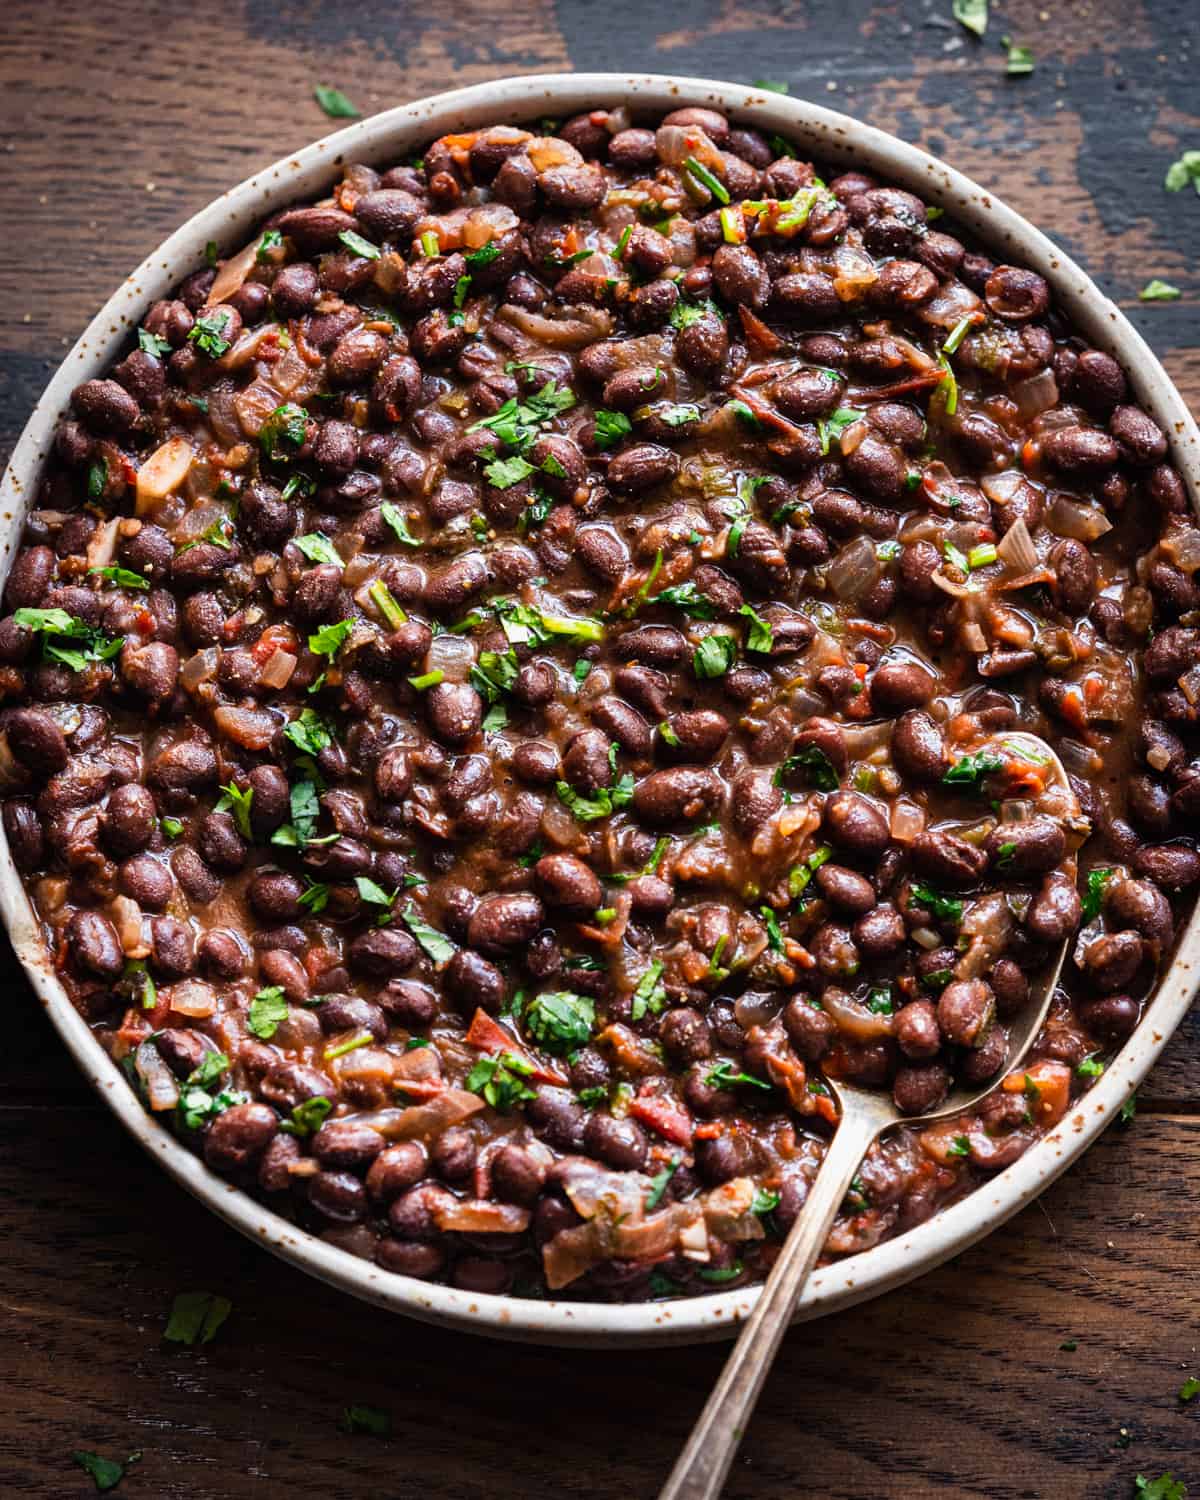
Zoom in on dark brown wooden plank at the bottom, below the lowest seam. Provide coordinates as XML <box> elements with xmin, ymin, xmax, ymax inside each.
<box><xmin>0</xmin><ymin>1109</ymin><xmax>1200</xmax><ymax>1500</ymax></box>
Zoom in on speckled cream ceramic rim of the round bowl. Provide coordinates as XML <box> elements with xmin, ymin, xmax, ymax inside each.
<box><xmin>0</xmin><ymin>74</ymin><xmax>1200</xmax><ymax>1347</ymax></box>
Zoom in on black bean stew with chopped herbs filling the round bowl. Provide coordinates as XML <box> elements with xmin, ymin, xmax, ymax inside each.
<box><xmin>11</xmin><ymin>108</ymin><xmax>1200</xmax><ymax>1301</ymax></box>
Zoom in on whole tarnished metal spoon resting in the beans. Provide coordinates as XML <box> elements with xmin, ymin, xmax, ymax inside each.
<box><xmin>659</xmin><ymin>734</ymin><xmax>1088</xmax><ymax>1500</ymax></box>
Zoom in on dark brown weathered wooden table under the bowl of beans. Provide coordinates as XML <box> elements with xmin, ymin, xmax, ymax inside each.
<box><xmin>0</xmin><ymin>0</ymin><xmax>1200</xmax><ymax>1500</ymax></box>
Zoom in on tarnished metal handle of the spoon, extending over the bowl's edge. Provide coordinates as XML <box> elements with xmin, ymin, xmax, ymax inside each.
<box><xmin>659</xmin><ymin>1109</ymin><xmax>879</xmax><ymax>1500</ymax></box>
